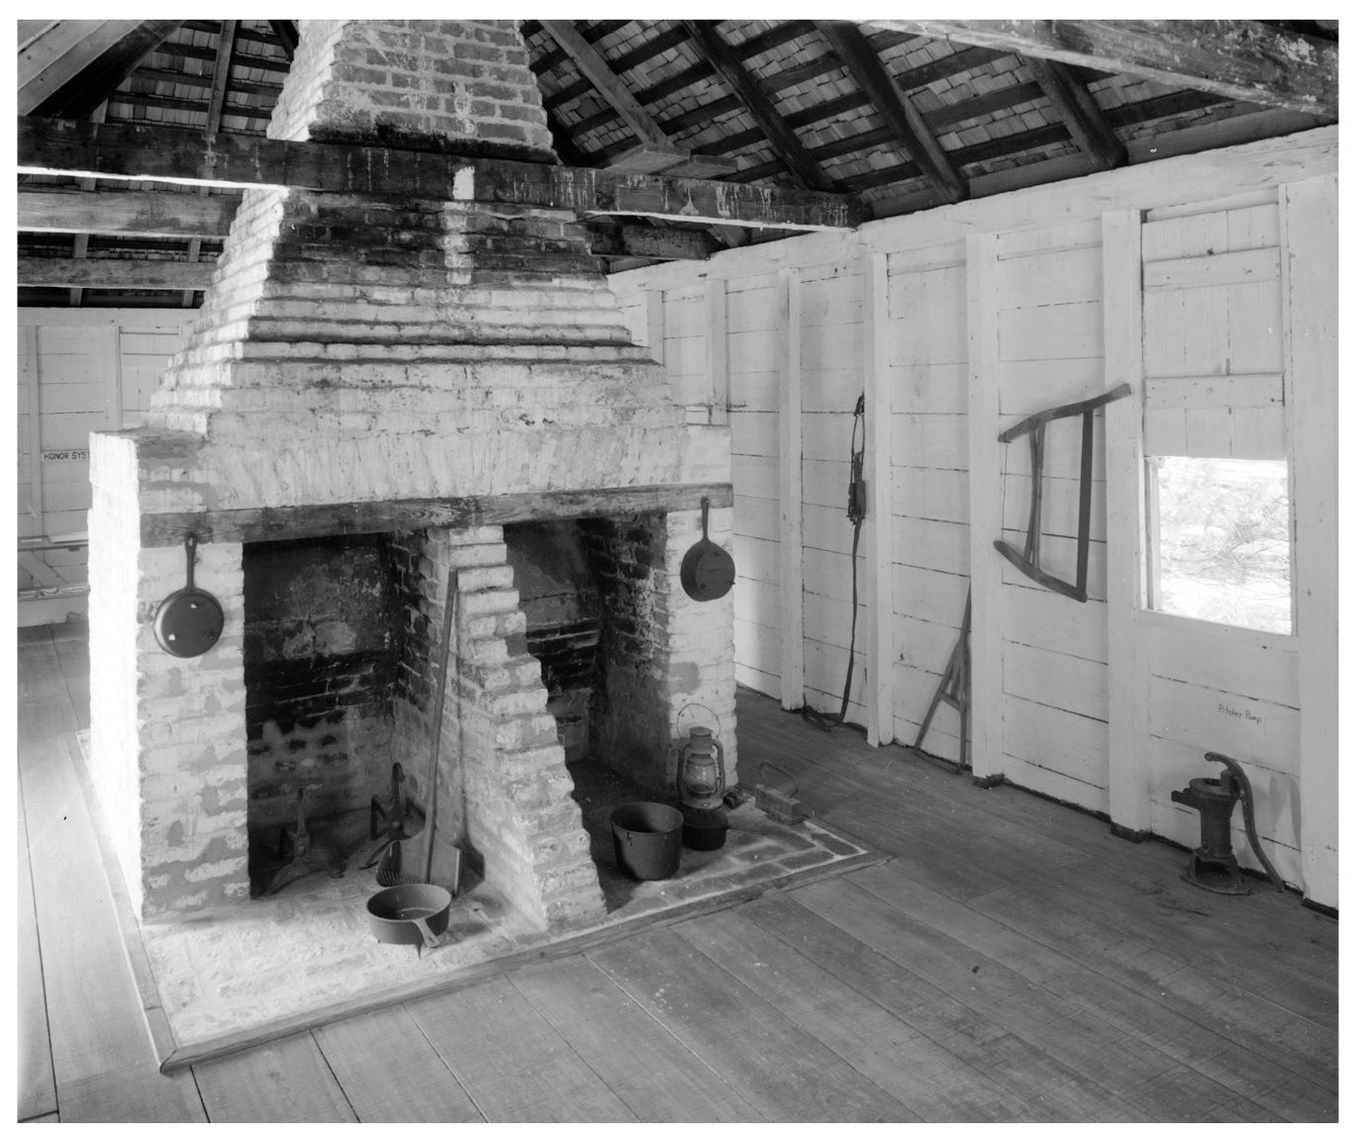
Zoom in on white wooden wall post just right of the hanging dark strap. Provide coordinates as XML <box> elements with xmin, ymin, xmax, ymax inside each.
<box><xmin>861</xmin><ymin>253</ymin><xmax>894</xmax><ymax>746</ymax></box>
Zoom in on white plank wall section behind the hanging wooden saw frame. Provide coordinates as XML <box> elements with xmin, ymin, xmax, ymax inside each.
<box><xmin>988</xmin><ymin>222</ymin><xmax>1109</xmax><ymax>812</ymax></box>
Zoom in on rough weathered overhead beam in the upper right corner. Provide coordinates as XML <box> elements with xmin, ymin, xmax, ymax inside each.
<box><xmin>868</xmin><ymin>20</ymin><xmax>1339</xmax><ymax>118</ymax></box>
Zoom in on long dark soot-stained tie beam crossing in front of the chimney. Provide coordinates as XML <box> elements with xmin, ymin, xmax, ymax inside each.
<box><xmin>18</xmin><ymin>117</ymin><xmax>869</xmax><ymax>229</ymax></box>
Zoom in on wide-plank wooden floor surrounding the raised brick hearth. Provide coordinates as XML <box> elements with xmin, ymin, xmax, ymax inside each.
<box><xmin>19</xmin><ymin>630</ymin><xmax>1338</xmax><ymax>1122</ymax></box>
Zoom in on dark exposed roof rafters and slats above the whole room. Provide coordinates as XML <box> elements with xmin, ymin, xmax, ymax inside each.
<box><xmin>18</xmin><ymin>20</ymin><xmax>1338</xmax><ymax>305</ymax></box>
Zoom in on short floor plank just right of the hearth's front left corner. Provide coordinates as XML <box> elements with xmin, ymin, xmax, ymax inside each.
<box><xmin>192</xmin><ymin>1032</ymin><xmax>357</xmax><ymax>1122</ymax></box>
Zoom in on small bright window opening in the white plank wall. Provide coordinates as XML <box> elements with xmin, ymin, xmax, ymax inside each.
<box><xmin>1148</xmin><ymin>455</ymin><xmax>1293</xmax><ymax>635</ymax></box>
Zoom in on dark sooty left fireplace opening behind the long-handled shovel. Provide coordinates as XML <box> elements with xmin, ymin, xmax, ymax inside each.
<box><xmin>242</xmin><ymin>534</ymin><xmax>408</xmax><ymax>894</ymax></box>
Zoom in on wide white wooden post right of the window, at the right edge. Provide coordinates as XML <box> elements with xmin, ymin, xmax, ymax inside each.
<box><xmin>1280</xmin><ymin>176</ymin><xmax>1339</xmax><ymax>908</ymax></box>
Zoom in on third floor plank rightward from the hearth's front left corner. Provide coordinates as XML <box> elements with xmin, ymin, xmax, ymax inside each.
<box><xmin>406</xmin><ymin>977</ymin><xmax>635</xmax><ymax>1123</ymax></box>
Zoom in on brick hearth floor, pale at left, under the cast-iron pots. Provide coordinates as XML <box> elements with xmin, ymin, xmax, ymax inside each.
<box><xmin>80</xmin><ymin>733</ymin><xmax>873</xmax><ymax>1069</ymax></box>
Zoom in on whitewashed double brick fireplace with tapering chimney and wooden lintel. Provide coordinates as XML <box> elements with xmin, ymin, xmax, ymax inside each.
<box><xmin>89</xmin><ymin>20</ymin><xmax>737</xmax><ymax>929</ymax></box>
